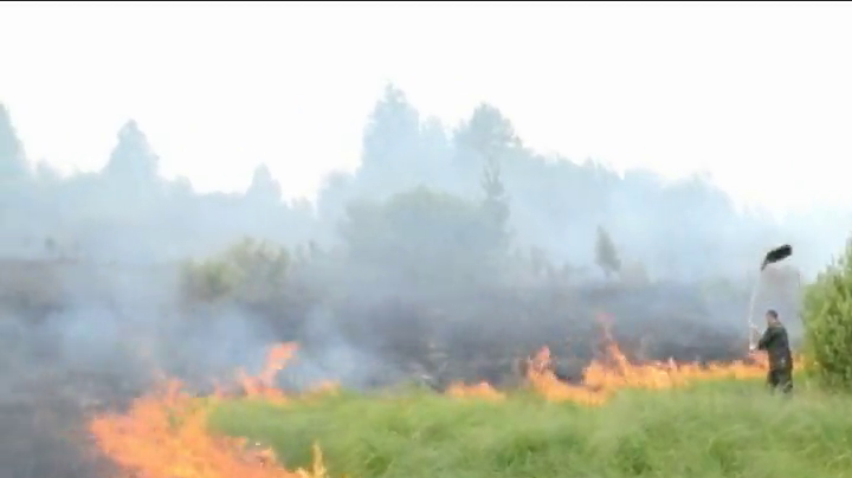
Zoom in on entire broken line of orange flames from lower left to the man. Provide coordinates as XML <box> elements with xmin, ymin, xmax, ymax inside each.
<box><xmin>90</xmin><ymin>333</ymin><xmax>784</xmax><ymax>478</ymax></box>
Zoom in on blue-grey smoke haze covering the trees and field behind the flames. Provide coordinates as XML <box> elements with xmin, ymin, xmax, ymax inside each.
<box><xmin>0</xmin><ymin>86</ymin><xmax>848</xmax><ymax>477</ymax></box>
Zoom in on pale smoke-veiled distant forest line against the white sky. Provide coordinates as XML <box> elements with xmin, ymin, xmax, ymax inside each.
<box><xmin>0</xmin><ymin>86</ymin><xmax>845</xmax><ymax>280</ymax></box>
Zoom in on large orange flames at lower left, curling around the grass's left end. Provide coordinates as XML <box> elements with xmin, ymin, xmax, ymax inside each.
<box><xmin>89</xmin><ymin>344</ymin><xmax>335</xmax><ymax>478</ymax></box>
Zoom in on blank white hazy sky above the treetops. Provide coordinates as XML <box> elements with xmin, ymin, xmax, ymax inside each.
<box><xmin>0</xmin><ymin>2</ymin><xmax>852</xmax><ymax>215</ymax></box>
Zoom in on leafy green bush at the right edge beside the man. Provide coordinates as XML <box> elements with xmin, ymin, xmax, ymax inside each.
<box><xmin>803</xmin><ymin>240</ymin><xmax>852</xmax><ymax>390</ymax></box>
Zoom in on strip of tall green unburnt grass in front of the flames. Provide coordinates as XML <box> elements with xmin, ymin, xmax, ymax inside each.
<box><xmin>210</xmin><ymin>382</ymin><xmax>852</xmax><ymax>478</ymax></box>
